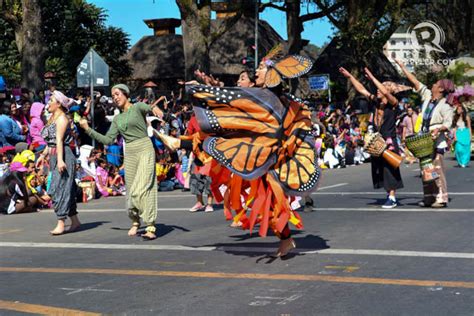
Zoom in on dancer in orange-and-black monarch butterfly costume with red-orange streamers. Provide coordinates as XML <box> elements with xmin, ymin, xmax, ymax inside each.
<box><xmin>161</xmin><ymin>47</ymin><xmax>320</xmax><ymax>256</ymax></box>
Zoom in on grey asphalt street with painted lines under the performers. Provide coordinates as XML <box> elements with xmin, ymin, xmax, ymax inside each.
<box><xmin>0</xmin><ymin>154</ymin><xmax>474</xmax><ymax>315</ymax></box>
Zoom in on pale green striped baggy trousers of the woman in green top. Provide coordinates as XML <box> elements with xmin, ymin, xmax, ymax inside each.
<box><xmin>124</xmin><ymin>137</ymin><xmax>158</xmax><ymax>232</ymax></box>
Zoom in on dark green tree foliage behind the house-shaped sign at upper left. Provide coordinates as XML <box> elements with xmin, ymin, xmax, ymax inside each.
<box><xmin>45</xmin><ymin>0</ymin><xmax>131</xmax><ymax>87</ymax></box>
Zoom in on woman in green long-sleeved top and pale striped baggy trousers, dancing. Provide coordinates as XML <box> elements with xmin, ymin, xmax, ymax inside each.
<box><xmin>80</xmin><ymin>84</ymin><xmax>163</xmax><ymax>240</ymax></box>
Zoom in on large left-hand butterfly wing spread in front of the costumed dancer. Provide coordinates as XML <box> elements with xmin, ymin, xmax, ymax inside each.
<box><xmin>187</xmin><ymin>86</ymin><xmax>286</xmax><ymax>180</ymax></box>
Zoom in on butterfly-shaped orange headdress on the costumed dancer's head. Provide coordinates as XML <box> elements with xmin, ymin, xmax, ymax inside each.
<box><xmin>262</xmin><ymin>44</ymin><xmax>313</xmax><ymax>88</ymax></box>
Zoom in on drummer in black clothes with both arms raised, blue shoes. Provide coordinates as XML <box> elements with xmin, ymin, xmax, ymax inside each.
<box><xmin>339</xmin><ymin>67</ymin><xmax>403</xmax><ymax>209</ymax></box>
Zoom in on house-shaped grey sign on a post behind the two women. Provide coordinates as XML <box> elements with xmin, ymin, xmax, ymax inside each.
<box><xmin>76</xmin><ymin>48</ymin><xmax>109</xmax><ymax>147</ymax></box>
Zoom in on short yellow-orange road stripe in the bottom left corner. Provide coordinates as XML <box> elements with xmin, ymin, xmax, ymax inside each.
<box><xmin>0</xmin><ymin>300</ymin><xmax>101</xmax><ymax>316</ymax></box>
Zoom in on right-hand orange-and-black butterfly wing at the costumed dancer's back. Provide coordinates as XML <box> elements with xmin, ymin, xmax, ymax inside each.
<box><xmin>270</xmin><ymin>102</ymin><xmax>321</xmax><ymax>195</ymax></box>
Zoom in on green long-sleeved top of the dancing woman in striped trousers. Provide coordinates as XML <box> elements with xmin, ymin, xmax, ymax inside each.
<box><xmin>86</xmin><ymin>102</ymin><xmax>150</xmax><ymax>145</ymax></box>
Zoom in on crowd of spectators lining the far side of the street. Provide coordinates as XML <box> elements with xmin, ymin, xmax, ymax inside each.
<box><xmin>0</xmin><ymin>81</ymin><xmax>470</xmax><ymax>213</ymax></box>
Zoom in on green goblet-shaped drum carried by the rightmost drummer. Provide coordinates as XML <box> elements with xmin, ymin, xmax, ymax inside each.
<box><xmin>405</xmin><ymin>133</ymin><xmax>439</xmax><ymax>182</ymax></box>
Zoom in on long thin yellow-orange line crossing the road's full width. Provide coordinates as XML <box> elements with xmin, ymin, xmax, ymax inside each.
<box><xmin>0</xmin><ymin>267</ymin><xmax>474</xmax><ymax>289</ymax></box>
